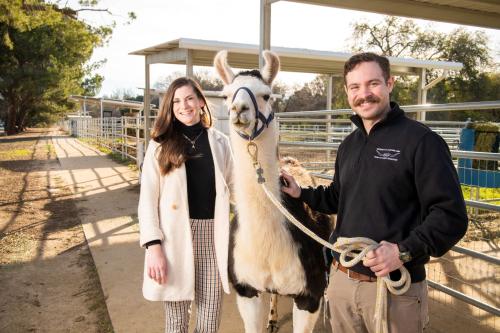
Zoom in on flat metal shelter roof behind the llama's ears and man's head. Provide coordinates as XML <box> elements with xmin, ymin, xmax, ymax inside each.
<box><xmin>129</xmin><ymin>38</ymin><xmax>463</xmax><ymax>75</ymax></box>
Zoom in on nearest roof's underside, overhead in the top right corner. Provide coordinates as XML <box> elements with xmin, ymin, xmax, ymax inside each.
<box><xmin>282</xmin><ymin>0</ymin><xmax>500</xmax><ymax>29</ymax></box>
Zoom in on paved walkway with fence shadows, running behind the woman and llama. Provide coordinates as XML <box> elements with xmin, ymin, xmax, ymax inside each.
<box><xmin>48</xmin><ymin>136</ymin><xmax>326</xmax><ymax>333</ymax></box>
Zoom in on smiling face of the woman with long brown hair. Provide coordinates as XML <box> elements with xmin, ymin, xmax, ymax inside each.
<box><xmin>173</xmin><ymin>85</ymin><xmax>205</xmax><ymax>126</ymax></box>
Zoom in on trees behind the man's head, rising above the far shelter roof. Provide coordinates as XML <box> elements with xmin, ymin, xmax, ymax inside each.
<box><xmin>352</xmin><ymin>16</ymin><xmax>499</xmax><ymax>120</ymax></box>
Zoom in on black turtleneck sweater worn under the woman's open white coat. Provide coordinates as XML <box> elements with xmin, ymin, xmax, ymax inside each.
<box><xmin>176</xmin><ymin>121</ymin><xmax>215</xmax><ymax>219</ymax></box>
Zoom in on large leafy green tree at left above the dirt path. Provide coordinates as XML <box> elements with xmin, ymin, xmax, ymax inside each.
<box><xmin>0</xmin><ymin>0</ymin><xmax>135</xmax><ymax>134</ymax></box>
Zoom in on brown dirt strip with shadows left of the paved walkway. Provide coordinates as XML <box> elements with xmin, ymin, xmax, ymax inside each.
<box><xmin>0</xmin><ymin>130</ymin><xmax>112</xmax><ymax>332</ymax></box>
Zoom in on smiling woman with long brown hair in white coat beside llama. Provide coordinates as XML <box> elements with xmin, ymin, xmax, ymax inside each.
<box><xmin>139</xmin><ymin>77</ymin><xmax>233</xmax><ymax>332</ymax></box>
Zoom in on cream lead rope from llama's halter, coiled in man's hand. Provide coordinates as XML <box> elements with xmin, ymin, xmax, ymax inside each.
<box><xmin>247</xmin><ymin>141</ymin><xmax>411</xmax><ymax>333</ymax></box>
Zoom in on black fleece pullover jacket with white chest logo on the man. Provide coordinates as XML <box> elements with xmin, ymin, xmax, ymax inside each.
<box><xmin>301</xmin><ymin>102</ymin><xmax>467</xmax><ymax>282</ymax></box>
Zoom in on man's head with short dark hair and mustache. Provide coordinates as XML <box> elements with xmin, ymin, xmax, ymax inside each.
<box><xmin>345</xmin><ymin>61</ymin><xmax>394</xmax><ymax>122</ymax></box>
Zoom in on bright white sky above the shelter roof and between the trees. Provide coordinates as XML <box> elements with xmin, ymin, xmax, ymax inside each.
<box><xmin>71</xmin><ymin>0</ymin><xmax>500</xmax><ymax>96</ymax></box>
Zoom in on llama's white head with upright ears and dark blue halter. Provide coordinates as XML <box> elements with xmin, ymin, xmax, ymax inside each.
<box><xmin>214</xmin><ymin>50</ymin><xmax>280</xmax><ymax>139</ymax></box>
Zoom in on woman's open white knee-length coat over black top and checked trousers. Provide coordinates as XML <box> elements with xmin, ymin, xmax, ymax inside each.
<box><xmin>138</xmin><ymin>128</ymin><xmax>233</xmax><ymax>301</ymax></box>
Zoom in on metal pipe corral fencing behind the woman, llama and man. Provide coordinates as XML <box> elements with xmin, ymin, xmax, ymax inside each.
<box><xmin>61</xmin><ymin>102</ymin><xmax>500</xmax><ymax>333</ymax></box>
